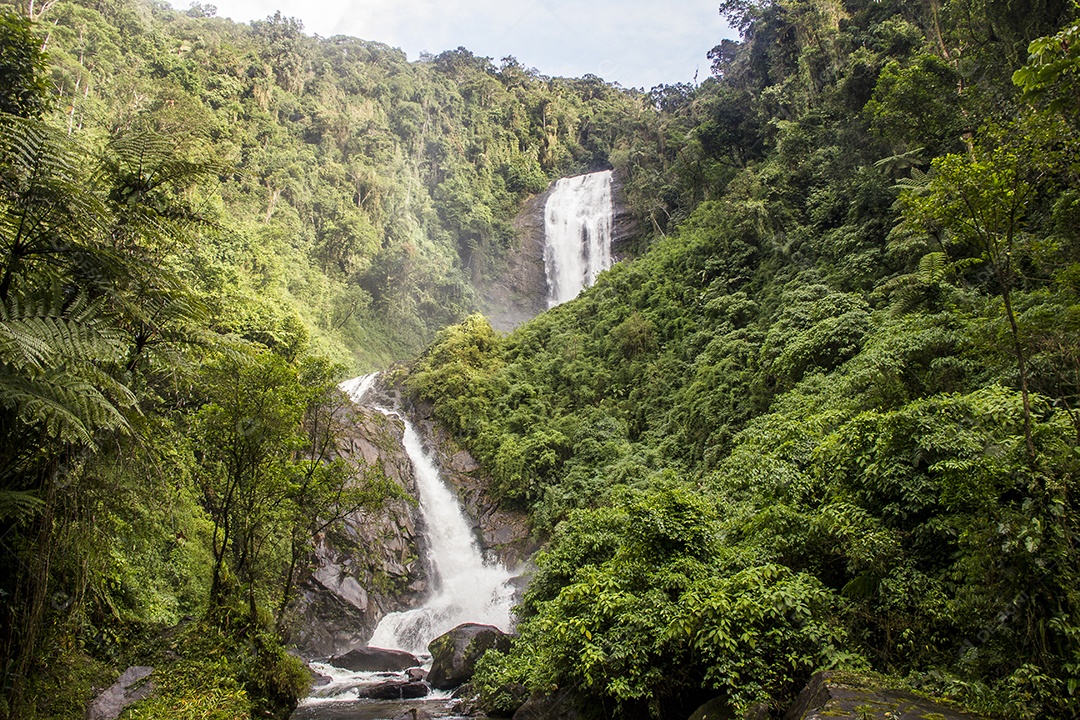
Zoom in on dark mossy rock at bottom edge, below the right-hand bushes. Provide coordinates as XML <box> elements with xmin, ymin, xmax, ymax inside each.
<box><xmin>786</xmin><ymin>670</ymin><xmax>981</xmax><ymax>720</ymax></box>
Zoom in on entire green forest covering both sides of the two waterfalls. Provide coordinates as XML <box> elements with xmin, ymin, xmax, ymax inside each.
<box><xmin>6</xmin><ymin>0</ymin><xmax>1080</xmax><ymax>719</ymax></box>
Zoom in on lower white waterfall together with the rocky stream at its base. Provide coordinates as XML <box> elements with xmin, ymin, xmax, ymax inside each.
<box><xmin>292</xmin><ymin>375</ymin><xmax>515</xmax><ymax>720</ymax></box>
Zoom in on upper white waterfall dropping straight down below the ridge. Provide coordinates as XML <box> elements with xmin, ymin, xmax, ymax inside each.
<box><xmin>543</xmin><ymin>171</ymin><xmax>612</xmax><ymax>308</ymax></box>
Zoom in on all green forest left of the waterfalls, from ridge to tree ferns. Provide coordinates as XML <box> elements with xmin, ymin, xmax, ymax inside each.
<box><xmin>0</xmin><ymin>0</ymin><xmax>664</xmax><ymax>719</ymax></box>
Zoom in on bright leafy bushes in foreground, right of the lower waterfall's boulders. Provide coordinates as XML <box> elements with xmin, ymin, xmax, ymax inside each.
<box><xmin>476</xmin><ymin>483</ymin><xmax>842</xmax><ymax>717</ymax></box>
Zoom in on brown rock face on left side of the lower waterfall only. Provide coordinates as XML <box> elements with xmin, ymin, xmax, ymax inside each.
<box><xmin>292</xmin><ymin>407</ymin><xmax>428</xmax><ymax>658</ymax></box>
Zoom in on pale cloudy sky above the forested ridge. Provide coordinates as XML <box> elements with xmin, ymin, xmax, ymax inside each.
<box><xmin>172</xmin><ymin>0</ymin><xmax>738</xmax><ymax>90</ymax></box>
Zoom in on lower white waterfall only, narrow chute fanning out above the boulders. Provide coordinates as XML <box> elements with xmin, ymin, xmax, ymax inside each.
<box><xmin>340</xmin><ymin>375</ymin><xmax>514</xmax><ymax>654</ymax></box>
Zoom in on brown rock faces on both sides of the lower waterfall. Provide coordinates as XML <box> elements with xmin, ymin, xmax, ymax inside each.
<box><xmin>292</xmin><ymin>383</ymin><xmax>537</xmax><ymax>658</ymax></box>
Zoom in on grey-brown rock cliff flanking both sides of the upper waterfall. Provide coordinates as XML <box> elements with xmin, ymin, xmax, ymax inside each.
<box><xmin>476</xmin><ymin>172</ymin><xmax>638</xmax><ymax>332</ymax></box>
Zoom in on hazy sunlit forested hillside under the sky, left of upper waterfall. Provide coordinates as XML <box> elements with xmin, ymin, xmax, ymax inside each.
<box><xmin>15</xmin><ymin>0</ymin><xmax>649</xmax><ymax>368</ymax></box>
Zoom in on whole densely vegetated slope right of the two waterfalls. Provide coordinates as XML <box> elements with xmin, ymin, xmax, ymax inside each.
<box><xmin>407</xmin><ymin>0</ymin><xmax>1080</xmax><ymax>718</ymax></box>
